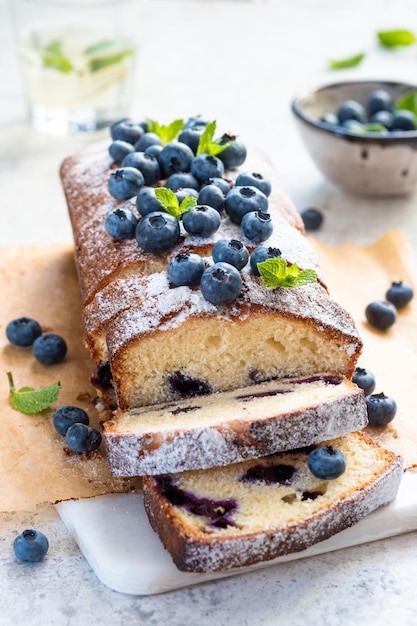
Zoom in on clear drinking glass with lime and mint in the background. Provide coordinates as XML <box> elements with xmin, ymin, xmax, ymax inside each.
<box><xmin>9</xmin><ymin>0</ymin><xmax>146</xmax><ymax>135</ymax></box>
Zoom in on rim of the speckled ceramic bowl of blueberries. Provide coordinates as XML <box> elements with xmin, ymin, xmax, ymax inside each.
<box><xmin>291</xmin><ymin>78</ymin><xmax>417</xmax><ymax>144</ymax></box>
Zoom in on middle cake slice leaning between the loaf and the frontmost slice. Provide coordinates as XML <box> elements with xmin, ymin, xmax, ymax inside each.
<box><xmin>104</xmin><ymin>374</ymin><xmax>368</xmax><ymax>476</ymax></box>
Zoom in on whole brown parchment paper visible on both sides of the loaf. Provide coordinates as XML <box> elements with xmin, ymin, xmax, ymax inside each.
<box><xmin>0</xmin><ymin>231</ymin><xmax>417</xmax><ymax>511</ymax></box>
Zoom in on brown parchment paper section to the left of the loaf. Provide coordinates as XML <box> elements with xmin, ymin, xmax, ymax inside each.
<box><xmin>0</xmin><ymin>246</ymin><xmax>140</xmax><ymax>511</ymax></box>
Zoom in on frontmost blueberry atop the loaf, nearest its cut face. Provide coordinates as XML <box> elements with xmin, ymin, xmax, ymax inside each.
<box><xmin>200</xmin><ymin>263</ymin><xmax>242</xmax><ymax>305</ymax></box>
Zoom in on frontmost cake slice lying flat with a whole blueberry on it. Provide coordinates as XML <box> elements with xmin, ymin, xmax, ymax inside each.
<box><xmin>143</xmin><ymin>432</ymin><xmax>403</xmax><ymax>572</ymax></box>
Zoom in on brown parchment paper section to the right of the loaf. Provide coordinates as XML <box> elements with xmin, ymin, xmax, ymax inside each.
<box><xmin>311</xmin><ymin>230</ymin><xmax>417</xmax><ymax>469</ymax></box>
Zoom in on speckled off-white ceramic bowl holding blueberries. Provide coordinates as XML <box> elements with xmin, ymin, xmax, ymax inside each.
<box><xmin>291</xmin><ymin>80</ymin><xmax>417</xmax><ymax>196</ymax></box>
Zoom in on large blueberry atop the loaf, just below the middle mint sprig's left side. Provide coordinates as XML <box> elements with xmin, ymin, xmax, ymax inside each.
<box><xmin>135</xmin><ymin>211</ymin><xmax>180</xmax><ymax>252</ymax></box>
